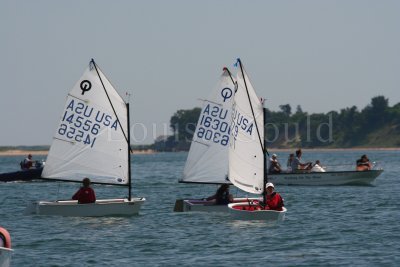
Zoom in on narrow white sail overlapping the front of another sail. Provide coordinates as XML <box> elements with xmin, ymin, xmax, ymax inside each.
<box><xmin>229</xmin><ymin>62</ymin><xmax>264</xmax><ymax>194</ymax></box>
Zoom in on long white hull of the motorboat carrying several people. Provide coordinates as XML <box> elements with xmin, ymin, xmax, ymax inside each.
<box><xmin>268</xmin><ymin>170</ymin><xmax>383</xmax><ymax>185</ymax></box>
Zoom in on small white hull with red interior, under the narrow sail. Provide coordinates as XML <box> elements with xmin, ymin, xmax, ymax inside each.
<box><xmin>228</xmin><ymin>203</ymin><xmax>287</xmax><ymax>222</ymax></box>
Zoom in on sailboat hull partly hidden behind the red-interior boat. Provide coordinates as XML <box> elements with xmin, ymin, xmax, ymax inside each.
<box><xmin>174</xmin><ymin>198</ymin><xmax>261</xmax><ymax>212</ymax></box>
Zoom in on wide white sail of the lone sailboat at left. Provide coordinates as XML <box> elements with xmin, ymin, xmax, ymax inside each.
<box><xmin>42</xmin><ymin>61</ymin><xmax>129</xmax><ymax>184</ymax></box>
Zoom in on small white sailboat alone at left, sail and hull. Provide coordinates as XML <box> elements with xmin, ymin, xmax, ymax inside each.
<box><xmin>25</xmin><ymin>59</ymin><xmax>145</xmax><ymax>216</ymax></box>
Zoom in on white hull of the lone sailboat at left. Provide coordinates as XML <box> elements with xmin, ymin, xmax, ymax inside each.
<box><xmin>25</xmin><ymin>198</ymin><xmax>146</xmax><ymax>217</ymax></box>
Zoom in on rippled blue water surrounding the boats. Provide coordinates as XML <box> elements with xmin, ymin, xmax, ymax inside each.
<box><xmin>0</xmin><ymin>151</ymin><xmax>400</xmax><ymax>266</ymax></box>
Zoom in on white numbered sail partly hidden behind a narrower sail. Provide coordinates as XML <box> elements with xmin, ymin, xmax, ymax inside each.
<box><xmin>181</xmin><ymin>69</ymin><xmax>234</xmax><ymax>183</ymax></box>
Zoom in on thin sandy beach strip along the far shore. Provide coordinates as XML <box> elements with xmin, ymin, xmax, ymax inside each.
<box><xmin>0</xmin><ymin>147</ymin><xmax>400</xmax><ymax>156</ymax></box>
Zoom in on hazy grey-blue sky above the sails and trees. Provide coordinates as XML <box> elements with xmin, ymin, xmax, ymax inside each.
<box><xmin>0</xmin><ymin>0</ymin><xmax>400</xmax><ymax>146</ymax></box>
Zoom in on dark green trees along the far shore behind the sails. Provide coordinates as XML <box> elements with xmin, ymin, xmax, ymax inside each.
<box><xmin>148</xmin><ymin>96</ymin><xmax>400</xmax><ymax>151</ymax></box>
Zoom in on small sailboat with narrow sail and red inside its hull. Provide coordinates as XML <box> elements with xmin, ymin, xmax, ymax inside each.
<box><xmin>228</xmin><ymin>59</ymin><xmax>286</xmax><ymax>221</ymax></box>
